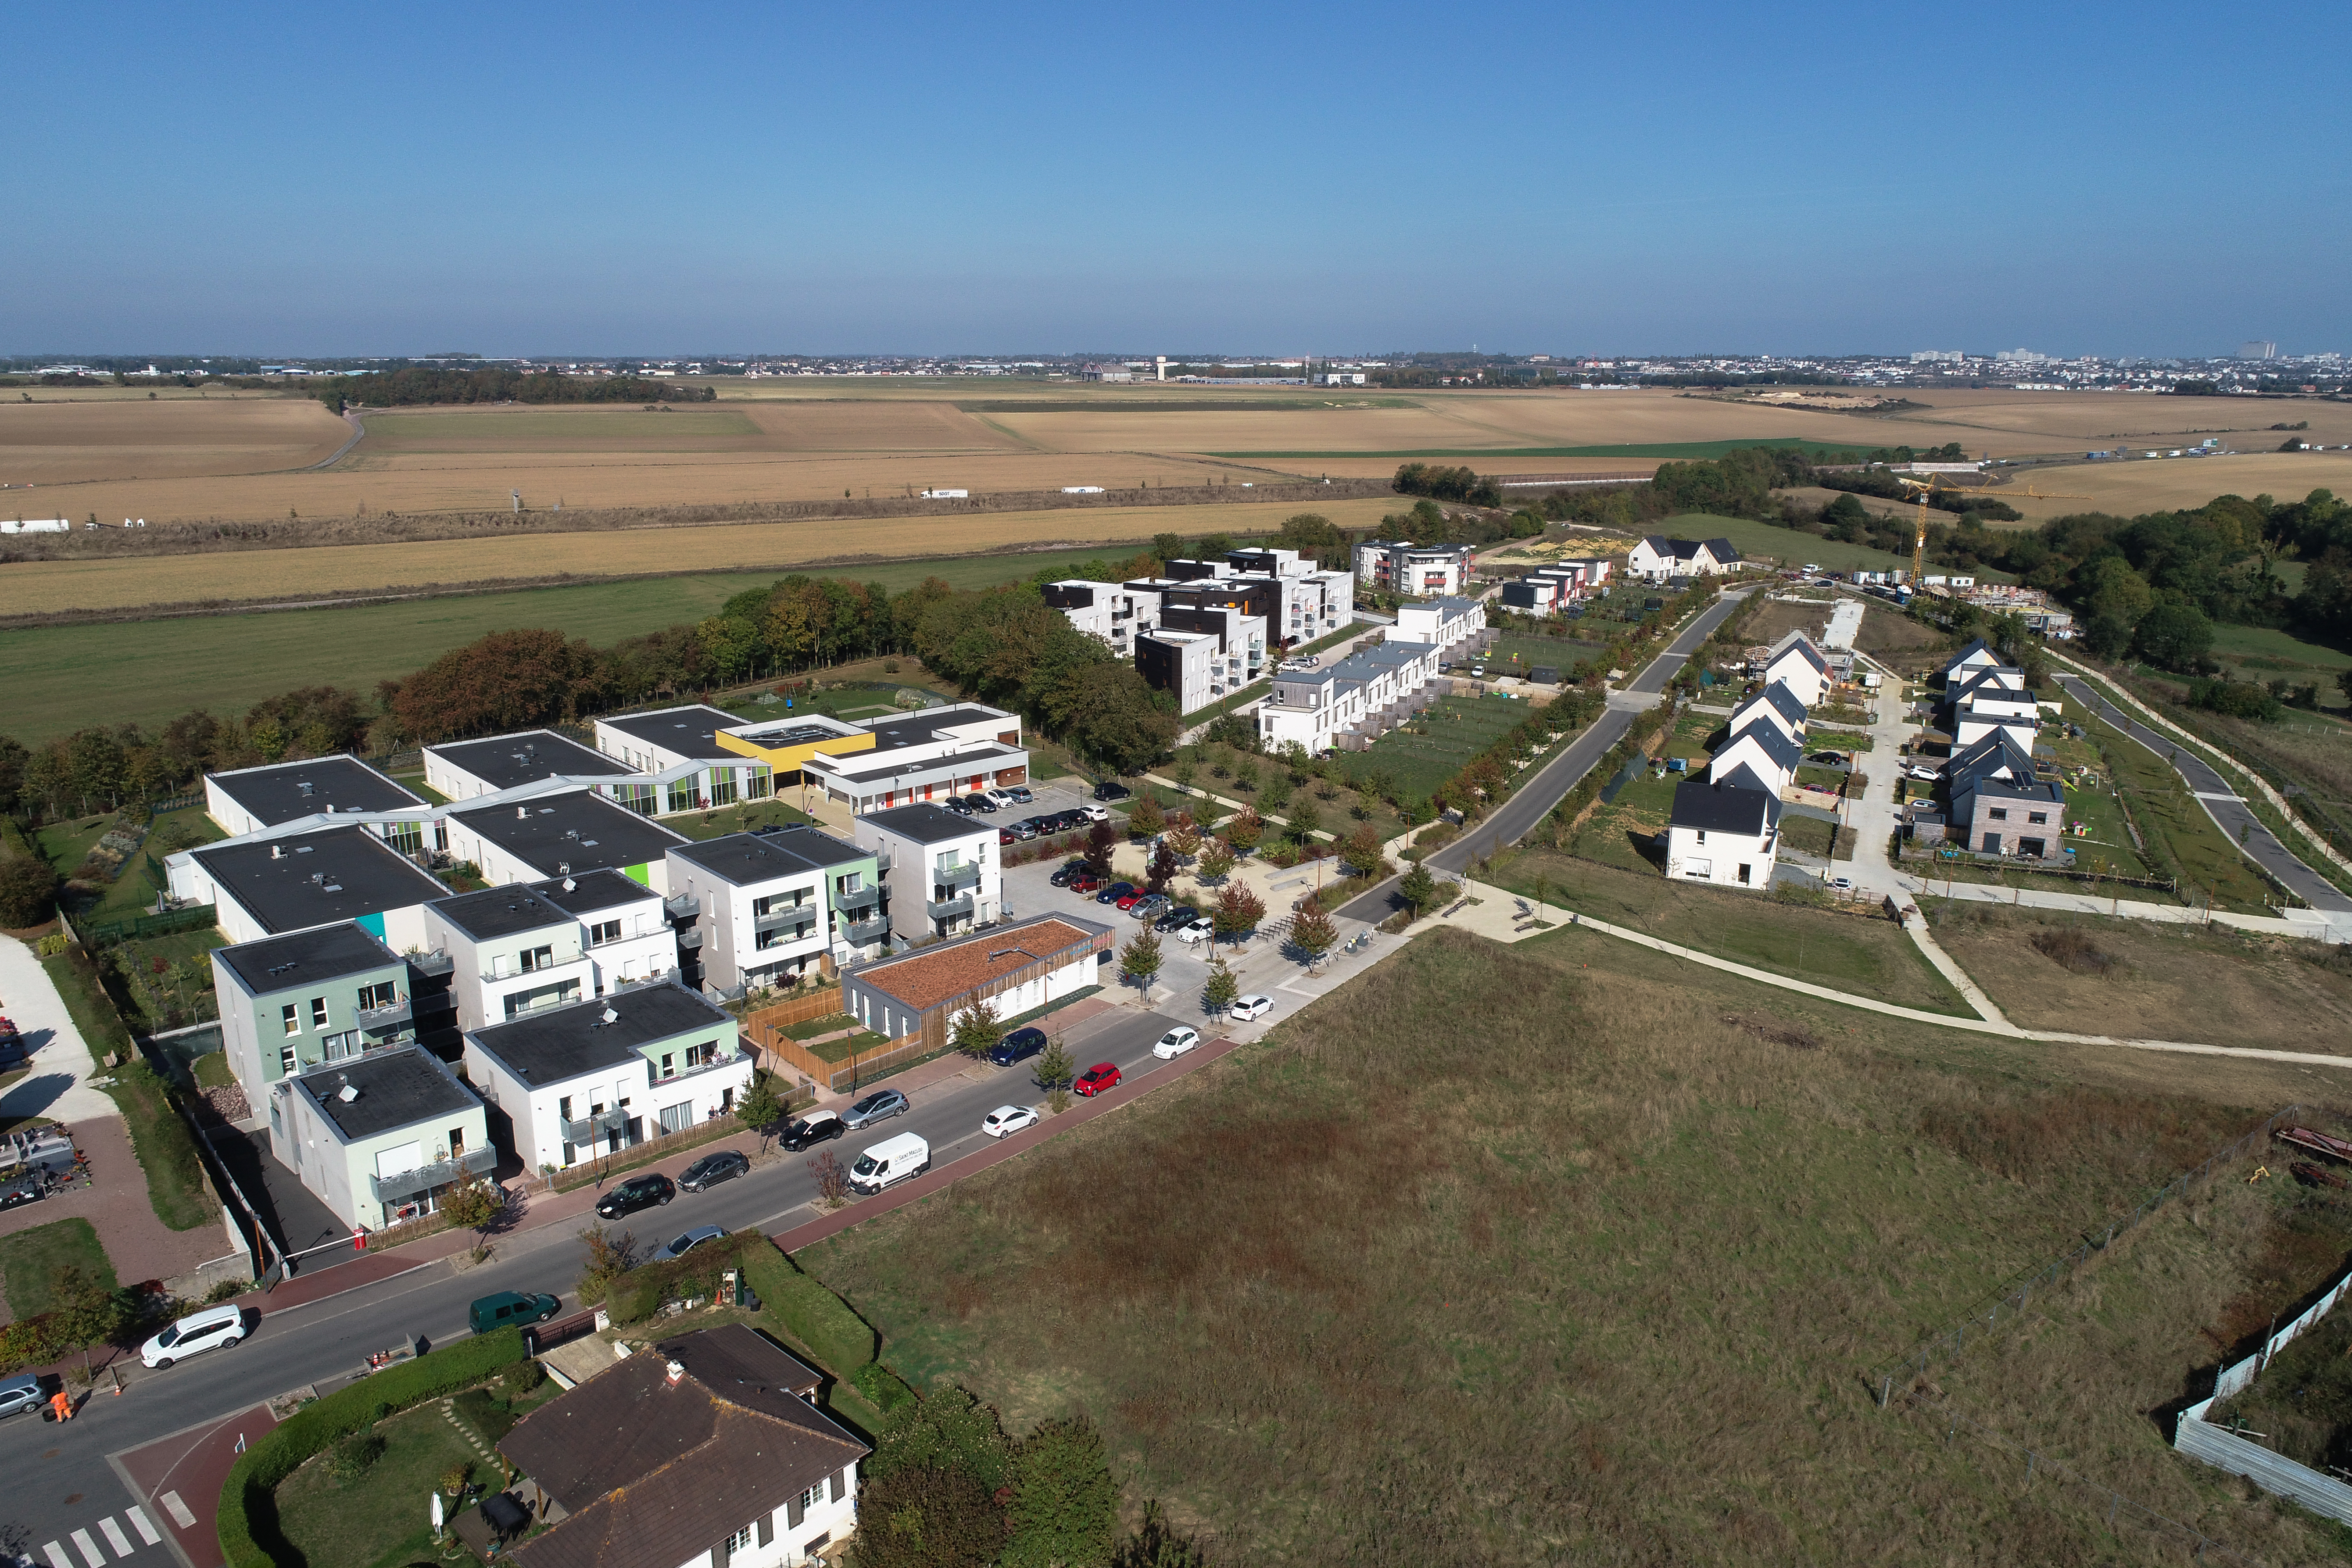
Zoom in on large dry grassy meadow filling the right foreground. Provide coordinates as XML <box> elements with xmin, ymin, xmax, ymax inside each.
<box><xmin>797</xmin><ymin>917</ymin><xmax>2347</xmax><ymax>1568</ymax></box>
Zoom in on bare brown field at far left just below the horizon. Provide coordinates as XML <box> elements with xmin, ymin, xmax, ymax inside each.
<box><xmin>0</xmin><ymin>397</ymin><xmax>351</xmax><ymax>487</ymax></box>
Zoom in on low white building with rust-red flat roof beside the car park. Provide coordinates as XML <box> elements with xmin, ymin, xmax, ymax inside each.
<box><xmin>842</xmin><ymin>914</ymin><xmax>1117</xmax><ymax>1051</ymax></box>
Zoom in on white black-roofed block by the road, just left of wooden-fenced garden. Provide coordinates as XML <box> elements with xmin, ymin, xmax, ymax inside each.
<box><xmin>465</xmin><ymin>983</ymin><xmax>753</xmax><ymax>1171</ymax></box>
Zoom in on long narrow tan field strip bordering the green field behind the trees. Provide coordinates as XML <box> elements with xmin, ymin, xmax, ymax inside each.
<box><xmin>0</xmin><ymin>501</ymin><xmax>1390</xmax><ymax>614</ymax></box>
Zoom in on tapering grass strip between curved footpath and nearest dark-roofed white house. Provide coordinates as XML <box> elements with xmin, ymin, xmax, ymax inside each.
<box><xmin>1491</xmin><ymin>846</ymin><xmax>1976</xmax><ymax>1018</ymax></box>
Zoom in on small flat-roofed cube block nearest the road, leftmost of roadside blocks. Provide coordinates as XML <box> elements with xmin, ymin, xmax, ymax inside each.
<box><xmin>268</xmin><ymin>1046</ymin><xmax>499</xmax><ymax>1229</ymax></box>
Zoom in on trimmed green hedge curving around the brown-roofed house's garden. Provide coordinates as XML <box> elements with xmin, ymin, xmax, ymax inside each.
<box><xmin>219</xmin><ymin>1328</ymin><xmax>525</xmax><ymax>1568</ymax></box>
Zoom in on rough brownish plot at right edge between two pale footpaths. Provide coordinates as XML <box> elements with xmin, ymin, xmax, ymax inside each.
<box><xmin>1922</xmin><ymin>888</ymin><xmax>2352</xmax><ymax>1056</ymax></box>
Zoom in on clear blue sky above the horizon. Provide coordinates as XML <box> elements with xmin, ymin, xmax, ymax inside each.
<box><xmin>0</xmin><ymin>0</ymin><xmax>2352</xmax><ymax>355</ymax></box>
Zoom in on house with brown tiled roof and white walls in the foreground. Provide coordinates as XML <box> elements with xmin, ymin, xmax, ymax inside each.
<box><xmin>499</xmin><ymin>1324</ymin><xmax>873</xmax><ymax>1568</ymax></box>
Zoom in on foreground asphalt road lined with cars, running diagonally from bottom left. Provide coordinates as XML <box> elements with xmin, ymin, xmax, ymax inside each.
<box><xmin>32</xmin><ymin>1004</ymin><xmax>1211</xmax><ymax>1568</ymax></box>
